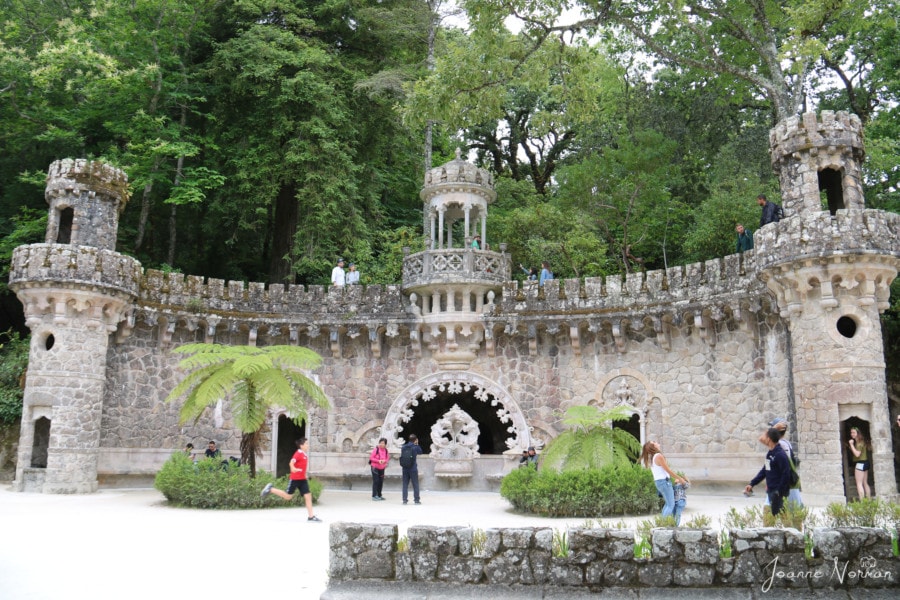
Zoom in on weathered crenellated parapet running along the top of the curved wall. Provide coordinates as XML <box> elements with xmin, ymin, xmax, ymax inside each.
<box><xmin>130</xmin><ymin>251</ymin><xmax>769</xmax><ymax>360</ymax></box>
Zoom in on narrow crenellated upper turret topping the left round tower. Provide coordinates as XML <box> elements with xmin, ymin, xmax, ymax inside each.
<box><xmin>44</xmin><ymin>159</ymin><xmax>128</xmax><ymax>250</ymax></box>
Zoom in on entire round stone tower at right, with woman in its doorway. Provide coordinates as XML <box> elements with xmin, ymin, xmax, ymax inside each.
<box><xmin>754</xmin><ymin>111</ymin><xmax>900</xmax><ymax>501</ymax></box>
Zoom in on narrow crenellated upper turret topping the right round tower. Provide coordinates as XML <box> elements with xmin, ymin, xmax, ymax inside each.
<box><xmin>769</xmin><ymin>110</ymin><xmax>865</xmax><ymax>217</ymax></box>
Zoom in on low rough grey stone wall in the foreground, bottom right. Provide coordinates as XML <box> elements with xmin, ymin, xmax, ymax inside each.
<box><xmin>329</xmin><ymin>523</ymin><xmax>900</xmax><ymax>592</ymax></box>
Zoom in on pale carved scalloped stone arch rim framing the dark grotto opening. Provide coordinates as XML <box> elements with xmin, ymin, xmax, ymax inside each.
<box><xmin>382</xmin><ymin>371</ymin><xmax>532</xmax><ymax>454</ymax></box>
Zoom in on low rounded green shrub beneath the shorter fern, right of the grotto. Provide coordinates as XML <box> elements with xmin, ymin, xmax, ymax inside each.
<box><xmin>500</xmin><ymin>465</ymin><xmax>659</xmax><ymax>518</ymax></box>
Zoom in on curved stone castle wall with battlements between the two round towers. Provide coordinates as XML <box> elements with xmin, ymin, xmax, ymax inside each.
<box><xmin>95</xmin><ymin>255</ymin><xmax>788</xmax><ymax>485</ymax></box>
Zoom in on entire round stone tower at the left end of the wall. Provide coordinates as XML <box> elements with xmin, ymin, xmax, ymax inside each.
<box><xmin>9</xmin><ymin>160</ymin><xmax>141</xmax><ymax>494</ymax></box>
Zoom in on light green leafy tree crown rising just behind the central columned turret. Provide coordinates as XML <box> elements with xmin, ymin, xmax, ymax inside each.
<box><xmin>405</xmin><ymin>31</ymin><xmax>620</xmax><ymax>195</ymax></box>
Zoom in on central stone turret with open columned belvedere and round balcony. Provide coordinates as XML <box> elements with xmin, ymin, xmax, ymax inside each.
<box><xmin>403</xmin><ymin>149</ymin><xmax>510</xmax><ymax>369</ymax></box>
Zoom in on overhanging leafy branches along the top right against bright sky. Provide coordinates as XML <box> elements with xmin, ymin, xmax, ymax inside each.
<box><xmin>464</xmin><ymin>0</ymin><xmax>856</xmax><ymax>121</ymax></box>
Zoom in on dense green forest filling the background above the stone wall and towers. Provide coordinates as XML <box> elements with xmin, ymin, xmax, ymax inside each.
<box><xmin>0</xmin><ymin>0</ymin><xmax>900</xmax><ymax>380</ymax></box>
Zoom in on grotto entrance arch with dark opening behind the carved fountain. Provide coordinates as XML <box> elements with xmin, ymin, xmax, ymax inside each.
<box><xmin>382</xmin><ymin>371</ymin><xmax>531</xmax><ymax>455</ymax></box>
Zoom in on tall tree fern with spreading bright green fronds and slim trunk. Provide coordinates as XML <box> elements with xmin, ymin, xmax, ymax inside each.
<box><xmin>166</xmin><ymin>344</ymin><xmax>329</xmax><ymax>477</ymax></box>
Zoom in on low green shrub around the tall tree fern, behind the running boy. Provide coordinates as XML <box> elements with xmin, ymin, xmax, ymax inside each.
<box><xmin>154</xmin><ymin>452</ymin><xmax>322</xmax><ymax>509</ymax></box>
